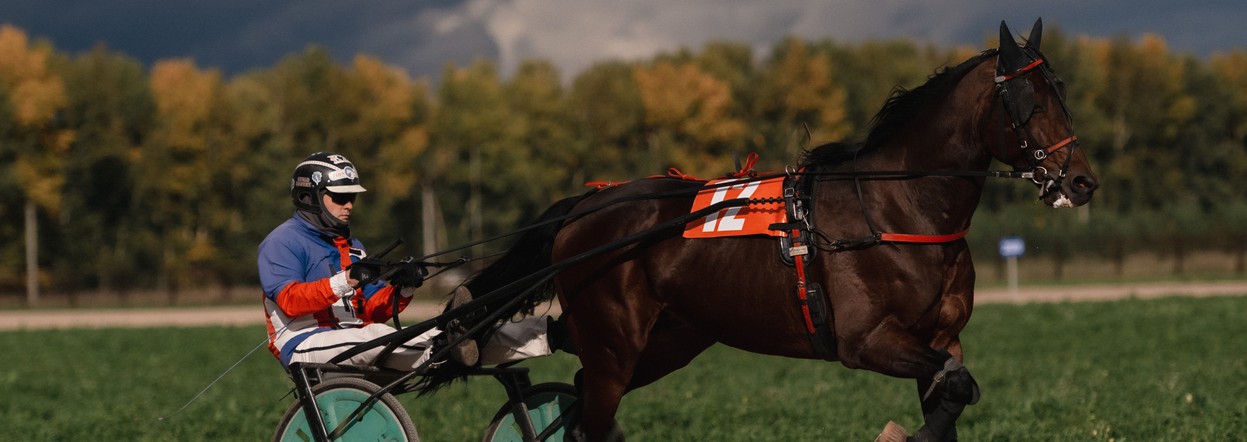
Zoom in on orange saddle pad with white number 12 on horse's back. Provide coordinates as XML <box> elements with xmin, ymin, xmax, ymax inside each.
<box><xmin>685</xmin><ymin>176</ymin><xmax>788</xmax><ymax>238</ymax></box>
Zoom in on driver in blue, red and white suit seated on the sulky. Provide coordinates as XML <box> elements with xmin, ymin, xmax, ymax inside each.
<box><xmin>257</xmin><ymin>152</ymin><xmax>552</xmax><ymax>370</ymax></box>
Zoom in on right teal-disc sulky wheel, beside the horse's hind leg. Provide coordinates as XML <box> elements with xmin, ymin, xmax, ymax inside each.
<box><xmin>483</xmin><ymin>382</ymin><xmax>577</xmax><ymax>442</ymax></box>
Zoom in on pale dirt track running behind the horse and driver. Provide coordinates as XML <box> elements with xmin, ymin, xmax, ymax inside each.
<box><xmin>0</xmin><ymin>281</ymin><xmax>1247</xmax><ymax>331</ymax></box>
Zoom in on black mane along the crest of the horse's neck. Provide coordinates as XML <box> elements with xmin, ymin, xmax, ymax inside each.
<box><xmin>801</xmin><ymin>49</ymin><xmax>996</xmax><ymax>166</ymax></box>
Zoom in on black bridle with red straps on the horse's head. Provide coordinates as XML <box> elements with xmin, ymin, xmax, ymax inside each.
<box><xmin>995</xmin><ymin>46</ymin><xmax>1079</xmax><ymax>199</ymax></box>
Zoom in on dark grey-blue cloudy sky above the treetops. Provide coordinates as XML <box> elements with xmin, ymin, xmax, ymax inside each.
<box><xmin>0</xmin><ymin>0</ymin><xmax>1247</xmax><ymax>76</ymax></box>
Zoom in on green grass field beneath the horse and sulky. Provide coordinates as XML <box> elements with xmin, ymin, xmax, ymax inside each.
<box><xmin>0</xmin><ymin>297</ymin><xmax>1247</xmax><ymax>442</ymax></box>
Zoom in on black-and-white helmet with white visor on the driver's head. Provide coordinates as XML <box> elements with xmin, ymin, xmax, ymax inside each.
<box><xmin>291</xmin><ymin>152</ymin><xmax>365</xmax><ymax>214</ymax></box>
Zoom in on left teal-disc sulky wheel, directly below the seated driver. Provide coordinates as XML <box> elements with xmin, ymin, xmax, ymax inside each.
<box><xmin>273</xmin><ymin>377</ymin><xmax>420</xmax><ymax>442</ymax></box>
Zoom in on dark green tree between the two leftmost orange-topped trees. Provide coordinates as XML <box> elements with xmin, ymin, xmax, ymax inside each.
<box><xmin>54</xmin><ymin>46</ymin><xmax>157</xmax><ymax>298</ymax></box>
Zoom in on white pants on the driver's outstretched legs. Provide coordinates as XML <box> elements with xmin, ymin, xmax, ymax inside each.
<box><xmin>291</xmin><ymin>316</ymin><xmax>554</xmax><ymax>370</ymax></box>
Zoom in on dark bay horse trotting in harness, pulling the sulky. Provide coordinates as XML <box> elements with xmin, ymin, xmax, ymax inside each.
<box><xmin>456</xmin><ymin>21</ymin><xmax>1097</xmax><ymax>441</ymax></box>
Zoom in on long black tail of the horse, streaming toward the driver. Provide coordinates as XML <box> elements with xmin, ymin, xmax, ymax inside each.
<box><xmin>415</xmin><ymin>192</ymin><xmax>592</xmax><ymax>395</ymax></box>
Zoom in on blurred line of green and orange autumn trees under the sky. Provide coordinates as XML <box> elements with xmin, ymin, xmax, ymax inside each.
<box><xmin>0</xmin><ymin>25</ymin><xmax>1247</xmax><ymax>302</ymax></box>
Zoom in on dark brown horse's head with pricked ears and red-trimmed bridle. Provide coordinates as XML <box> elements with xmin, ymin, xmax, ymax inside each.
<box><xmin>990</xmin><ymin>20</ymin><xmax>1099</xmax><ymax>207</ymax></box>
